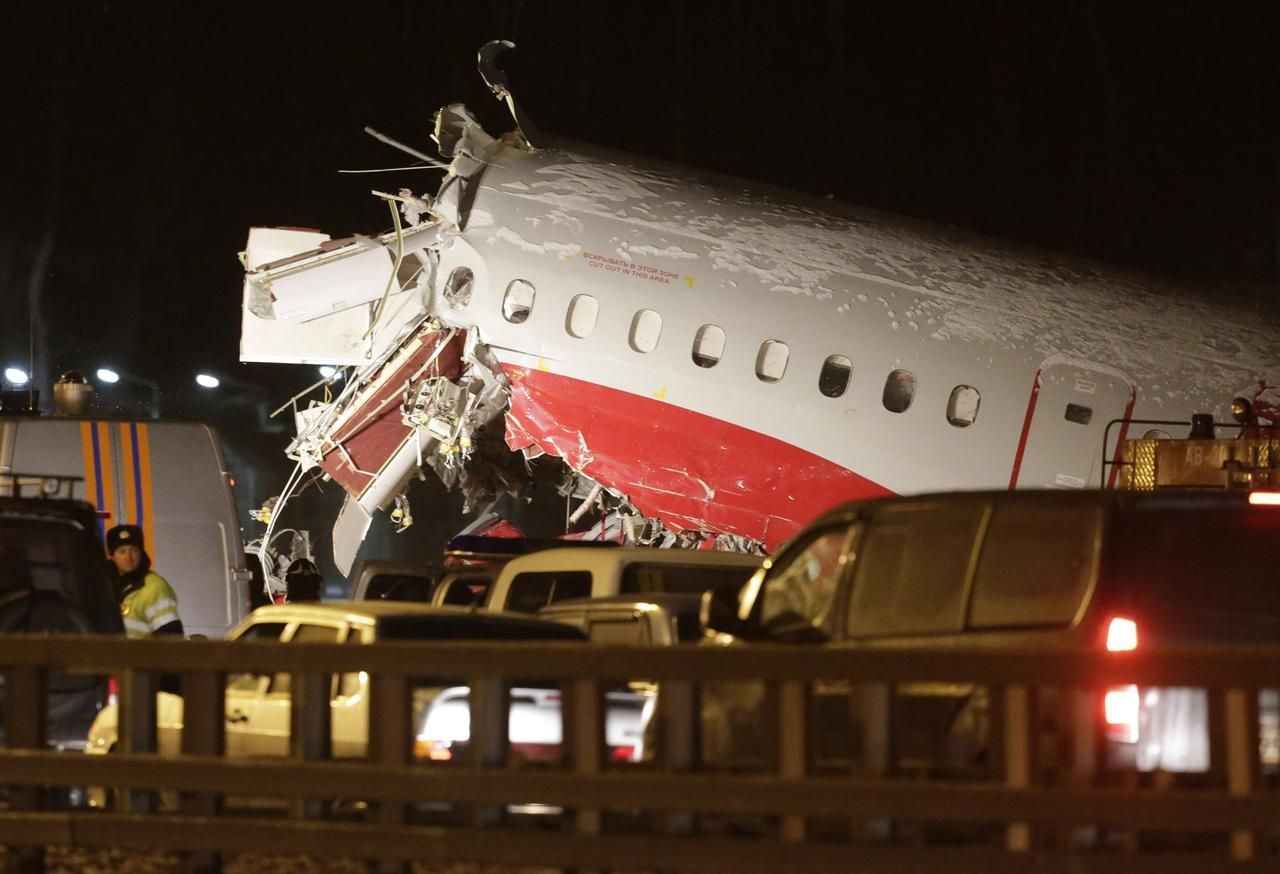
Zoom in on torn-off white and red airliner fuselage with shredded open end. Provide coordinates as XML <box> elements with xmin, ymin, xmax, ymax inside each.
<box><xmin>241</xmin><ymin>42</ymin><xmax>1280</xmax><ymax>568</ymax></box>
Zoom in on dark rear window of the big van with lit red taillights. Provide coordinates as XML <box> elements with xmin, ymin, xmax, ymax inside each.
<box><xmin>1103</xmin><ymin>505</ymin><xmax>1280</xmax><ymax>644</ymax></box>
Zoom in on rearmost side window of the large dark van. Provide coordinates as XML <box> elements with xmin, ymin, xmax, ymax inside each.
<box><xmin>969</xmin><ymin>500</ymin><xmax>1100</xmax><ymax>628</ymax></box>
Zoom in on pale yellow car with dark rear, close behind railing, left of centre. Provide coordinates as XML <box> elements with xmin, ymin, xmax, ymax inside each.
<box><xmin>87</xmin><ymin>601</ymin><xmax>585</xmax><ymax>806</ymax></box>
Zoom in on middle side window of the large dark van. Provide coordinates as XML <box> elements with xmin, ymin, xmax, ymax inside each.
<box><xmin>849</xmin><ymin>502</ymin><xmax>986</xmax><ymax>637</ymax></box>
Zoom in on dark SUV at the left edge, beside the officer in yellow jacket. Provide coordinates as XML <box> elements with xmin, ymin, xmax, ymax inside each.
<box><xmin>0</xmin><ymin>498</ymin><xmax>124</xmax><ymax>749</ymax></box>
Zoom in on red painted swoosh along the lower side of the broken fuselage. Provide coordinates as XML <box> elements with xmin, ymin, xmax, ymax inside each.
<box><xmin>503</xmin><ymin>365</ymin><xmax>891</xmax><ymax>549</ymax></box>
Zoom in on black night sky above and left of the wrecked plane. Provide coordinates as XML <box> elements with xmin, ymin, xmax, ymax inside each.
<box><xmin>0</xmin><ymin>0</ymin><xmax>1280</xmax><ymax>580</ymax></box>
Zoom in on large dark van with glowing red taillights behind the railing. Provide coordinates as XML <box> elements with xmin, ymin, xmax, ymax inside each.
<box><xmin>704</xmin><ymin>491</ymin><xmax>1280</xmax><ymax>773</ymax></box>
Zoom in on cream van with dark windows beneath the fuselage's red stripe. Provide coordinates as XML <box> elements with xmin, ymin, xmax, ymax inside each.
<box><xmin>476</xmin><ymin>546</ymin><xmax>764</xmax><ymax>613</ymax></box>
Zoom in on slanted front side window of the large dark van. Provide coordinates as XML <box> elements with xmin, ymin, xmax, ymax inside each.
<box><xmin>760</xmin><ymin>527</ymin><xmax>849</xmax><ymax>628</ymax></box>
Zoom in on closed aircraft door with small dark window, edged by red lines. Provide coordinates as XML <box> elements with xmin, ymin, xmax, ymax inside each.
<box><xmin>1009</xmin><ymin>361</ymin><xmax>1134</xmax><ymax>489</ymax></box>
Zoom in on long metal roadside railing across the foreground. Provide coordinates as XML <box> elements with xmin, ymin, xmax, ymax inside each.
<box><xmin>0</xmin><ymin>636</ymin><xmax>1280</xmax><ymax>874</ymax></box>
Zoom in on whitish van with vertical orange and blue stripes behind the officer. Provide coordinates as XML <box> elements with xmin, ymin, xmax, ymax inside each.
<box><xmin>0</xmin><ymin>416</ymin><xmax>250</xmax><ymax>637</ymax></box>
